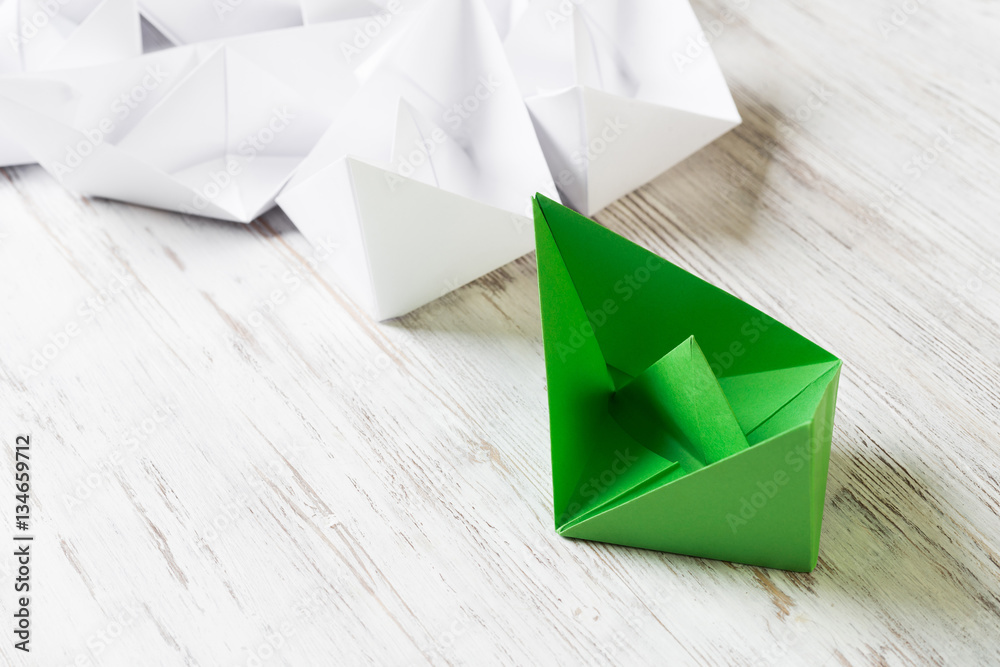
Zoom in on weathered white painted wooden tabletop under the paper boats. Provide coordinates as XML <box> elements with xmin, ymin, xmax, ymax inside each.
<box><xmin>0</xmin><ymin>0</ymin><xmax>1000</xmax><ymax>666</ymax></box>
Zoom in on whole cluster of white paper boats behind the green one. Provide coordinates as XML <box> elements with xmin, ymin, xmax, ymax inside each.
<box><xmin>0</xmin><ymin>0</ymin><xmax>740</xmax><ymax>319</ymax></box>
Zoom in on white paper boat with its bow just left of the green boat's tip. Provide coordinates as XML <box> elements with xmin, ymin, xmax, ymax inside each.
<box><xmin>277</xmin><ymin>0</ymin><xmax>555</xmax><ymax>319</ymax></box>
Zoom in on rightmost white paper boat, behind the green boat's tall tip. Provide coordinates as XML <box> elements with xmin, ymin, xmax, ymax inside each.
<box><xmin>500</xmin><ymin>0</ymin><xmax>740</xmax><ymax>215</ymax></box>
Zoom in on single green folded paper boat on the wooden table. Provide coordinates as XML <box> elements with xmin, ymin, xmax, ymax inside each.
<box><xmin>535</xmin><ymin>195</ymin><xmax>841</xmax><ymax>572</ymax></box>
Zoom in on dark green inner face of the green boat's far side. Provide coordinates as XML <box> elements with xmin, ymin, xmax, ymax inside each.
<box><xmin>536</xmin><ymin>195</ymin><xmax>836</xmax><ymax>377</ymax></box>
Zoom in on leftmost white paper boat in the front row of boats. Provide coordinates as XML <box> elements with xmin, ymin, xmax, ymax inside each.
<box><xmin>0</xmin><ymin>21</ymin><xmax>408</xmax><ymax>222</ymax></box>
